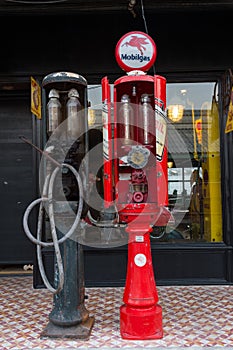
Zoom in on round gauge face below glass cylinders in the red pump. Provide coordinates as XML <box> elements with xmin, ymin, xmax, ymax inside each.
<box><xmin>127</xmin><ymin>146</ymin><xmax>150</xmax><ymax>169</ymax></box>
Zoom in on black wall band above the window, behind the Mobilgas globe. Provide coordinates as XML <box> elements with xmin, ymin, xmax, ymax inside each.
<box><xmin>0</xmin><ymin>8</ymin><xmax>233</xmax><ymax>82</ymax></box>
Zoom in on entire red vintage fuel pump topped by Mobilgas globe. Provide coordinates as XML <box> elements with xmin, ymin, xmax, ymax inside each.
<box><xmin>102</xmin><ymin>32</ymin><xmax>171</xmax><ymax>339</ymax></box>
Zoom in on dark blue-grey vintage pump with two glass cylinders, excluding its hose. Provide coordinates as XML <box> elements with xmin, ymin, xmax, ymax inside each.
<box><xmin>42</xmin><ymin>72</ymin><xmax>94</xmax><ymax>339</ymax></box>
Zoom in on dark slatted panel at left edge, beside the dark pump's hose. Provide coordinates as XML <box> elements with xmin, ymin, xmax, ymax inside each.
<box><xmin>0</xmin><ymin>93</ymin><xmax>35</xmax><ymax>264</ymax></box>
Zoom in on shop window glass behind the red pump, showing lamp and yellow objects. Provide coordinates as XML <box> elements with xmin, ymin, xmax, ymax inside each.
<box><xmin>88</xmin><ymin>82</ymin><xmax>222</xmax><ymax>243</ymax></box>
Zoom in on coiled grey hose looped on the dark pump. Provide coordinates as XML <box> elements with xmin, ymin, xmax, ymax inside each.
<box><xmin>23</xmin><ymin>163</ymin><xmax>83</xmax><ymax>294</ymax></box>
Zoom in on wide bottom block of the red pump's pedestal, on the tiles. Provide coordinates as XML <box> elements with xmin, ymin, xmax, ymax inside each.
<box><xmin>120</xmin><ymin>305</ymin><xmax>163</xmax><ymax>340</ymax></box>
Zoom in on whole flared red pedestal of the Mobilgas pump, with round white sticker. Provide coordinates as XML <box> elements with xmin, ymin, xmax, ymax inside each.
<box><xmin>120</xmin><ymin>223</ymin><xmax>163</xmax><ymax>340</ymax></box>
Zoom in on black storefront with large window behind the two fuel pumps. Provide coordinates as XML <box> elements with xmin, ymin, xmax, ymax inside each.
<box><xmin>0</xmin><ymin>2</ymin><xmax>233</xmax><ymax>287</ymax></box>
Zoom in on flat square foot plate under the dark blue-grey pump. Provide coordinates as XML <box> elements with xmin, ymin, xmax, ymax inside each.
<box><xmin>40</xmin><ymin>317</ymin><xmax>94</xmax><ymax>340</ymax></box>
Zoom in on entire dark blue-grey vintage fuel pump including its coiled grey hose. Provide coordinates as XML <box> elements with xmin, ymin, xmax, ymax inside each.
<box><xmin>23</xmin><ymin>72</ymin><xmax>94</xmax><ymax>339</ymax></box>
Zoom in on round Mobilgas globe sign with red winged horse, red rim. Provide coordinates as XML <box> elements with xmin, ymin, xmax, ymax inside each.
<box><xmin>115</xmin><ymin>31</ymin><xmax>157</xmax><ymax>72</ymax></box>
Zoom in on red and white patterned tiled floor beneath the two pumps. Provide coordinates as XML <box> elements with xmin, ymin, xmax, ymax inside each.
<box><xmin>0</xmin><ymin>276</ymin><xmax>233</xmax><ymax>350</ymax></box>
